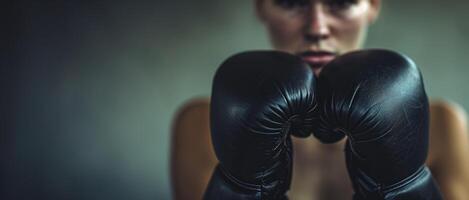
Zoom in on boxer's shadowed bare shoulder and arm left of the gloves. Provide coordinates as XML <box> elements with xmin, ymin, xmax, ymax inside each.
<box><xmin>170</xmin><ymin>98</ymin><xmax>218</xmax><ymax>200</ymax></box>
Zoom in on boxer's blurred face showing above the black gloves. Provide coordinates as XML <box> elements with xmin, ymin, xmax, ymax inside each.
<box><xmin>256</xmin><ymin>0</ymin><xmax>380</xmax><ymax>75</ymax></box>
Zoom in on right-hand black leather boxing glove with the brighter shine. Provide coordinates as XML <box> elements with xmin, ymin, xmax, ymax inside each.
<box><xmin>313</xmin><ymin>50</ymin><xmax>442</xmax><ymax>200</ymax></box>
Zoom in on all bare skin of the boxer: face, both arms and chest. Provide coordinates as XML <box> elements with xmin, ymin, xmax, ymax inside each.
<box><xmin>170</xmin><ymin>0</ymin><xmax>469</xmax><ymax>200</ymax></box>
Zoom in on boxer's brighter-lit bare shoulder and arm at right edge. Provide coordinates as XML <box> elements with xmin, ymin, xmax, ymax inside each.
<box><xmin>427</xmin><ymin>100</ymin><xmax>469</xmax><ymax>199</ymax></box>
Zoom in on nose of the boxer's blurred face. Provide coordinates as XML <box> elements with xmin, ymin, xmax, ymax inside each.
<box><xmin>305</xmin><ymin>3</ymin><xmax>330</xmax><ymax>42</ymax></box>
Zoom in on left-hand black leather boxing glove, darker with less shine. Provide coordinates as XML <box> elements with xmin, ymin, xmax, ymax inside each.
<box><xmin>204</xmin><ymin>51</ymin><xmax>316</xmax><ymax>199</ymax></box>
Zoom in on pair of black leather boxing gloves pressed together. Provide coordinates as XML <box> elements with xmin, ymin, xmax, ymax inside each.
<box><xmin>204</xmin><ymin>50</ymin><xmax>442</xmax><ymax>200</ymax></box>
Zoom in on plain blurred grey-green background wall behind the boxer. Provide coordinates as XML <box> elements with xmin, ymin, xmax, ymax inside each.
<box><xmin>4</xmin><ymin>0</ymin><xmax>469</xmax><ymax>200</ymax></box>
